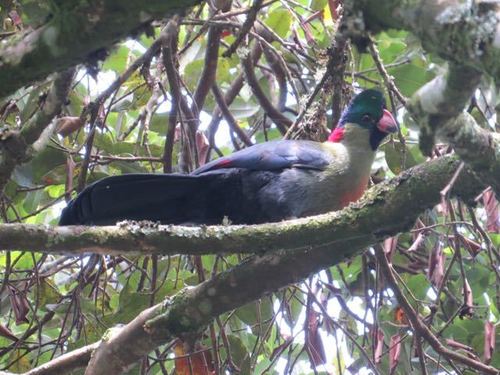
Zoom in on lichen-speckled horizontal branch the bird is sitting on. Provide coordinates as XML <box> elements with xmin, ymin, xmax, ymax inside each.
<box><xmin>0</xmin><ymin>157</ymin><xmax>486</xmax><ymax>255</ymax></box>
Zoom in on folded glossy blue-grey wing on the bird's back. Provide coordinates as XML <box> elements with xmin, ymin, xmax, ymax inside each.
<box><xmin>192</xmin><ymin>140</ymin><xmax>331</xmax><ymax>175</ymax></box>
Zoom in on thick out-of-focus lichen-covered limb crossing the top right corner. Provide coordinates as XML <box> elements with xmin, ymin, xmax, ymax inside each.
<box><xmin>345</xmin><ymin>0</ymin><xmax>500</xmax><ymax>78</ymax></box>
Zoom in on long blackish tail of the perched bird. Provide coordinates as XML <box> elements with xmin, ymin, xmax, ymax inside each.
<box><xmin>59</xmin><ymin>173</ymin><xmax>240</xmax><ymax>225</ymax></box>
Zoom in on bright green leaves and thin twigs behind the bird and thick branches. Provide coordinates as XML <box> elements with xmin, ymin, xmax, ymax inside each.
<box><xmin>0</xmin><ymin>0</ymin><xmax>500</xmax><ymax>374</ymax></box>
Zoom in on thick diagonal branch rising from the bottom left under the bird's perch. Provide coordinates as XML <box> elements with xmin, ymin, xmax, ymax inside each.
<box><xmin>72</xmin><ymin>158</ymin><xmax>490</xmax><ymax>375</ymax></box>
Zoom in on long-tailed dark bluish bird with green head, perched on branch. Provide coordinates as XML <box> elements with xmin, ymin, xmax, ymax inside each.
<box><xmin>59</xmin><ymin>89</ymin><xmax>398</xmax><ymax>226</ymax></box>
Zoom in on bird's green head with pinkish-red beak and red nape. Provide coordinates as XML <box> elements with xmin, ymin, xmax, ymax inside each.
<box><xmin>328</xmin><ymin>89</ymin><xmax>398</xmax><ymax>150</ymax></box>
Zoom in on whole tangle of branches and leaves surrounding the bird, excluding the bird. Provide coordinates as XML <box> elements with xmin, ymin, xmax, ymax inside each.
<box><xmin>0</xmin><ymin>0</ymin><xmax>500</xmax><ymax>375</ymax></box>
